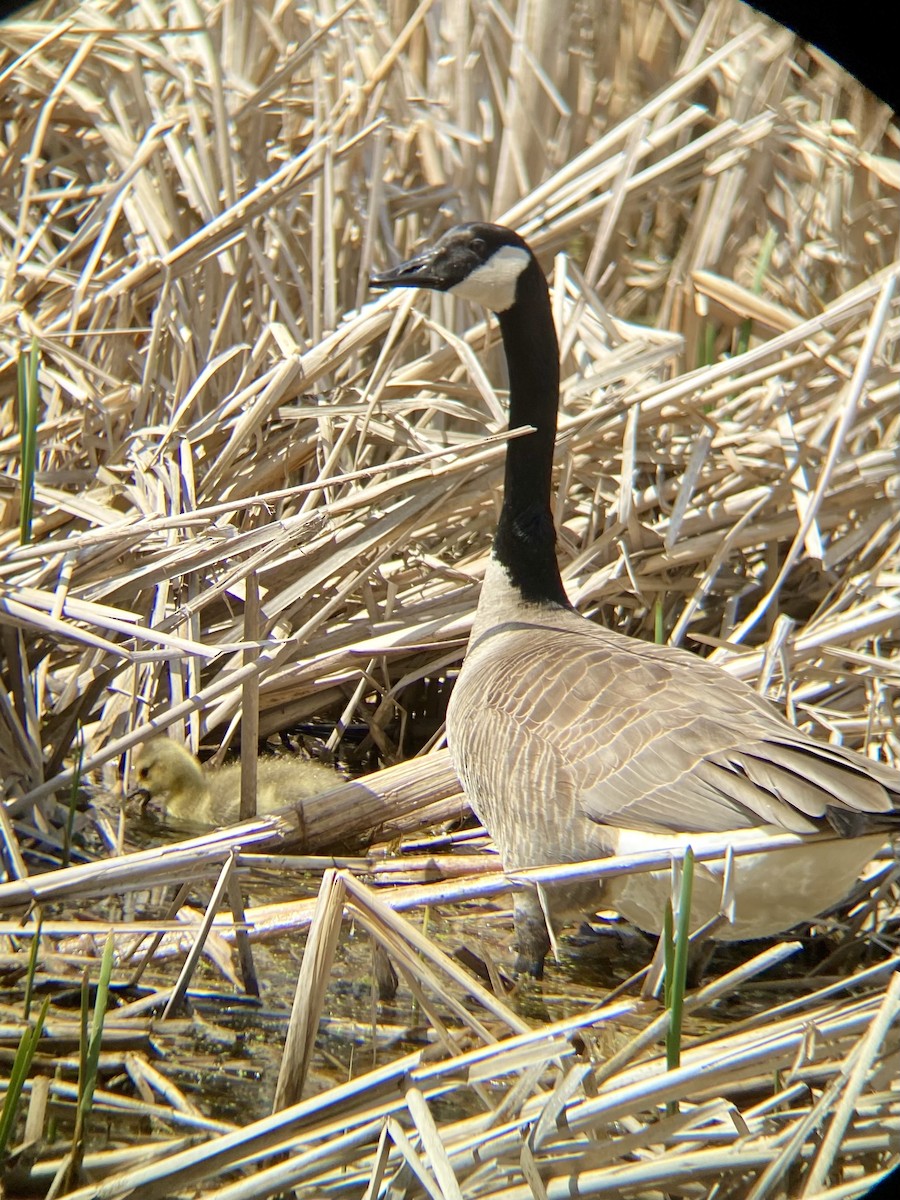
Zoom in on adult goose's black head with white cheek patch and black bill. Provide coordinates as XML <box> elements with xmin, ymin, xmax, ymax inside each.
<box><xmin>371</xmin><ymin>221</ymin><xmax>539</xmax><ymax>313</ymax></box>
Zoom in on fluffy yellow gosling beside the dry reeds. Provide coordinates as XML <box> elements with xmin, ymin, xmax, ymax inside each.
<box><xmin>128</xmin><ymin>737</ymin><xmax>341</xmax><ymax>827</ymax></box>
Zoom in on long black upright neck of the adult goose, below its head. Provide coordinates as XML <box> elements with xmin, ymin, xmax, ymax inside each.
<box><xmin>493</xmin><ymin>259</ymin><xmax>569</xmax><ymax>607</ymax></box>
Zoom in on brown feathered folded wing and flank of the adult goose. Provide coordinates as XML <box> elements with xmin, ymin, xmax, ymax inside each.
<box><xmin>448</xmin><ymin>613</ymin><xmax>900</xmax><ymax>835</ymax></box>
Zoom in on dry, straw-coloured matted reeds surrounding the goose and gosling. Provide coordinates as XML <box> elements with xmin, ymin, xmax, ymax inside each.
<box><xmin>0</xmin><ymin>0</ymin><xmax>900</xmax><ymax>1200</ymax></box>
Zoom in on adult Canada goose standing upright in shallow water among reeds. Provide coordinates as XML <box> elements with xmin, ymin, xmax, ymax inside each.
<box><xmin>372</xmin><ymin>222</ymin><xmax>900</xmax><ymax>974</ymax></box>
